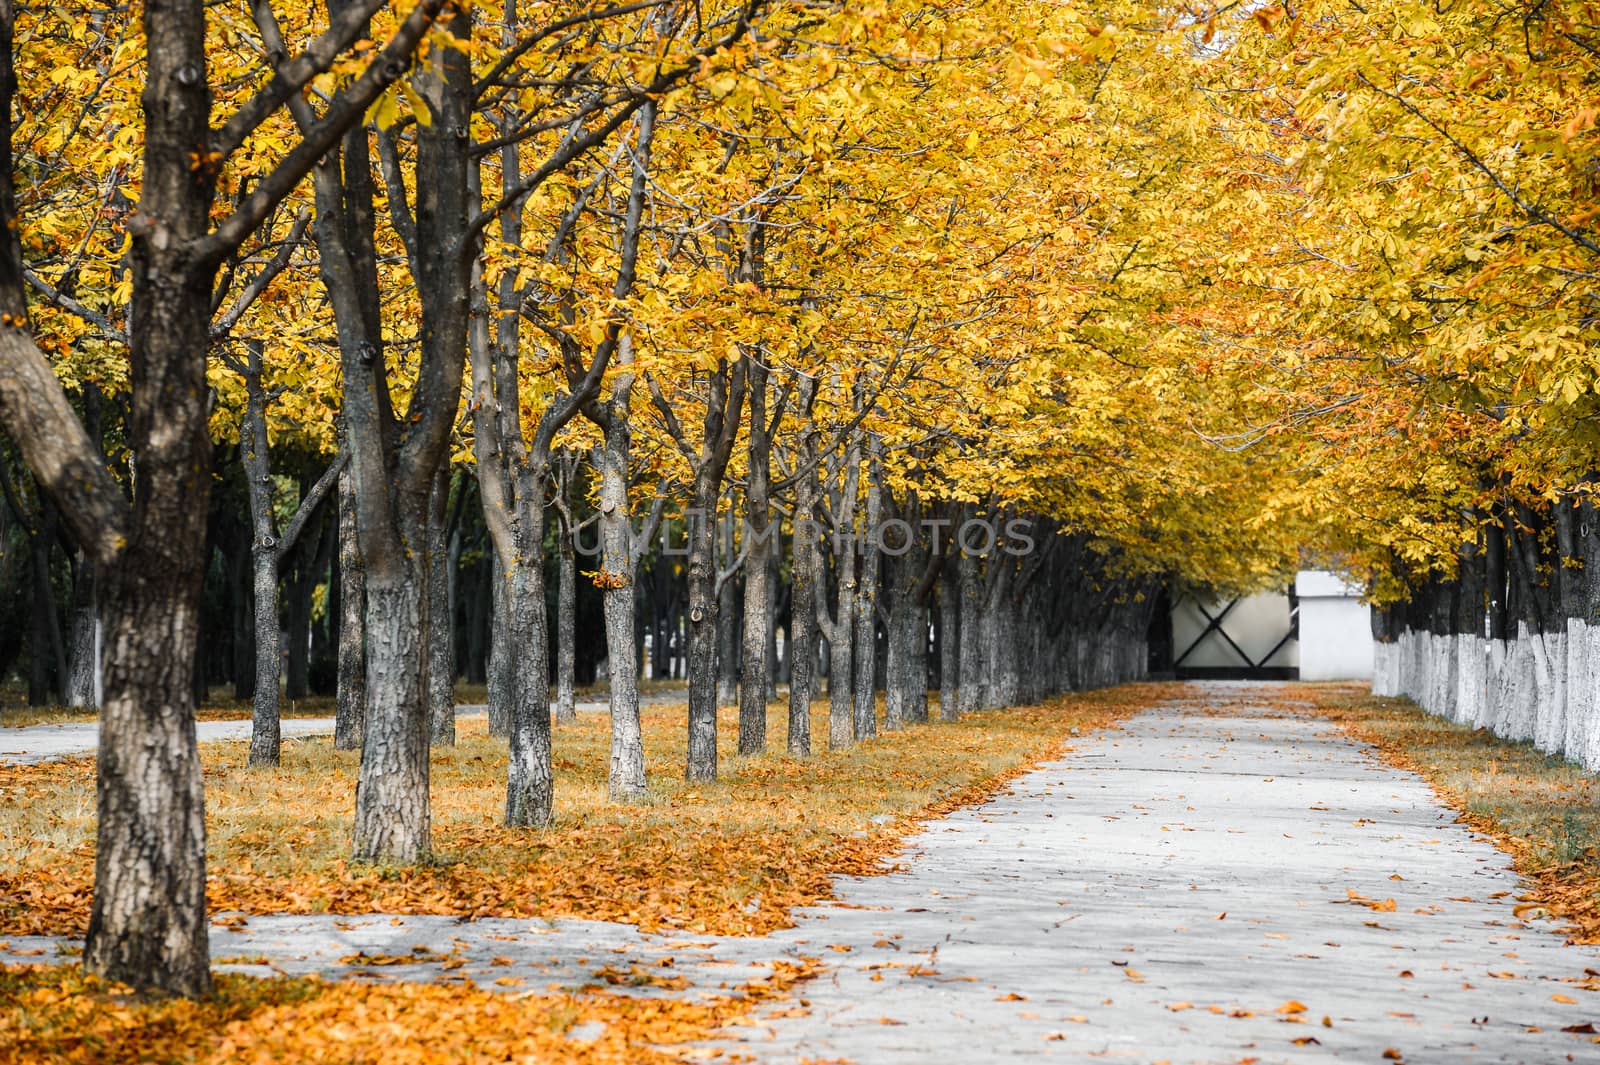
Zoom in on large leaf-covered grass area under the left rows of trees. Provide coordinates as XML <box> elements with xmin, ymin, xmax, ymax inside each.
<box><xmin>0</xmin><ymin>684</ymin><xmax>1182</xmax><ymax>934</ymax></box>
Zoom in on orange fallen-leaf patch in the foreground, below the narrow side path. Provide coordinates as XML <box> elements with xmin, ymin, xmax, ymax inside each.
<box><xmin>0</xmin><ymin>946</ymin><xmax>810</xmax><ymax>1065</ymax></box>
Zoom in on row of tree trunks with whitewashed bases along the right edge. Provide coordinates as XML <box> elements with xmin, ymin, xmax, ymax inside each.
<box><xmin>1373</xmin><ymin>496</ymin><xmax>1600</xmax><ymax>769</ymax></box>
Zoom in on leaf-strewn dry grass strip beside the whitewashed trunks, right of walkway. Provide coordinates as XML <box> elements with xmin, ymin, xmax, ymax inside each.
<box><xmin>1315</xmin><ymin>688</ymin><xmax>1600</xmax><ymax>942</ymax></box>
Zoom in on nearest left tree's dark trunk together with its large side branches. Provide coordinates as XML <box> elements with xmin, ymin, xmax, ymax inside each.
<box><xmin>0</xmin><ymin>0</ymin><xmax>442</xmax><ymax>995</ymax></box>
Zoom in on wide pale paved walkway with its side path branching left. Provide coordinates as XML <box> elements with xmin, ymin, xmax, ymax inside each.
<box><xmin>0</xmin><ymin>688</ymin><xmax>1600</xmax><ymax>1065</ymax></box>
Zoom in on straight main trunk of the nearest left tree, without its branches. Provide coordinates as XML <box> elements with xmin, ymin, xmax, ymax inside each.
<box><xmin>82</xmin><ymin>0</ymin><xmax>216</xmax><ymax>998</ymax></box>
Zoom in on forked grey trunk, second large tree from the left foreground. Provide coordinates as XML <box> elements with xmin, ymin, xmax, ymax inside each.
<box><xmin>347</xmin><ymin>0</ymin><xmax>477</xmax><ymax>864</ymax></box>
